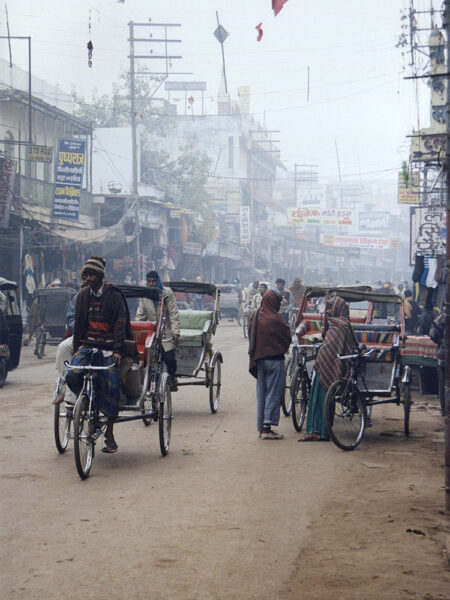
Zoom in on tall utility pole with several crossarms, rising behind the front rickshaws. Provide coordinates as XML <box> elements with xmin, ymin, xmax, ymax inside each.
<box><xmin>128</xmin><ymin>21</ymin><xmax>181</xmax><ymax>284</ymax></box>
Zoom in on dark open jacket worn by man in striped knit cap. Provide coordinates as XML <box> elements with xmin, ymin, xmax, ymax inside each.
<box><xmin>73</xmin><ymin>283</ymin><xmax>131</xmax><ymax>354</ymax></box>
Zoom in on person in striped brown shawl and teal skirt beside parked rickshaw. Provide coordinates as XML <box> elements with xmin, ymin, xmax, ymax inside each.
<box><xmin>299</xmin><ymin>296</ymin><xmax>358</xmax><ymax>442</ymax></box>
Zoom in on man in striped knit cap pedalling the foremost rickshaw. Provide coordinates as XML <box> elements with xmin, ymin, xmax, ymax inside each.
<box><xmin>66</xmin><ymin>256</ymin><xmax>131</xmax><ymax>453</ymax></box>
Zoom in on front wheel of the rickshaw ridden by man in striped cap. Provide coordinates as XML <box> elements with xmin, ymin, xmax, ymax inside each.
<box><xmin>73</xmin><ymin>395</ymin><xmax>94</xmax><ymax>479</ymax></box>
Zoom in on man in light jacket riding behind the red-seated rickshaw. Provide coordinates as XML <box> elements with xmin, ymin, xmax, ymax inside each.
<box><xmin>136</xmin><ymin>271</ymin><xmax>180</xmax><ymax>392</ymax></box>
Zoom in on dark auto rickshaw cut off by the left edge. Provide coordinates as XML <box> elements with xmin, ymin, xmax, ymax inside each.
<box><xmin>0</xmin><ymin>277</ymin><xmax>23</xmax><ymax>387</ymax></box>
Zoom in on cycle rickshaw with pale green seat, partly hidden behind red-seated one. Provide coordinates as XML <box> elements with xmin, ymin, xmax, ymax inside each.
<box><xmin>164</xmin><ymin>281</ymin><xmax>223</xmax><ymax>413</ymax></box>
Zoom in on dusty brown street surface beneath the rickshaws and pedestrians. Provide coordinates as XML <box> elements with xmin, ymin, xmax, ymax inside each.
<box><xmin>0</xmin><ymin>321</ymin><xmax>450</xmax><ymax>600</ymax></box>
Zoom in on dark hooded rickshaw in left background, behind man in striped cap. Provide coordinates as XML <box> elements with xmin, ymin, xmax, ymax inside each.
<box><xmin>34</xmin><ymin>287</ymin><xmax>76</xmax><ymax>358</ymax></box>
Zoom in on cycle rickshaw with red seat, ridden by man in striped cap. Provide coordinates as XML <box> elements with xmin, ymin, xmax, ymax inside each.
<box><xmin>54</xmin><ymin>285</ymin><xmax>173</xmax><ymax>479</ymax></box>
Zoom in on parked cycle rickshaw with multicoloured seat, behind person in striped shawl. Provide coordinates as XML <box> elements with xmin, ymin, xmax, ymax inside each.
<box><xmin>291</xmin><ymin>288</ymin><xmax>411</xmax><ymax>450</ymax></box>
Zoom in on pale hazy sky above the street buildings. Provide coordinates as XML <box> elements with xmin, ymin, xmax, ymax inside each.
<box><xmin>0</xmin><ymin>0</ymin><xmax>441</xmax><ymax>191</ymax></box>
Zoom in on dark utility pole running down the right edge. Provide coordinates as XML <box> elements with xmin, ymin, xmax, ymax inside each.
<box><xmin>444</xmin><ymin>0</ymin><xmax>450</xmax><ymax>512</ymax></box>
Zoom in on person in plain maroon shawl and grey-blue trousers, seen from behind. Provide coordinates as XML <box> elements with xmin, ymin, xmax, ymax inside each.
<box><xmin>248</xmin><ymin>290</ymin><xmax>291</xmax><ymax>440</ymax></box>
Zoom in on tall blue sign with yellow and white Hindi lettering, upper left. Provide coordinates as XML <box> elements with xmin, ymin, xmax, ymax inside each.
<box><xmin>52</xmin><ymin>139</ymin><xmax>86</xmax><ymax>221</ymax></box>
